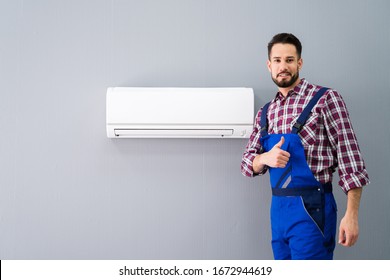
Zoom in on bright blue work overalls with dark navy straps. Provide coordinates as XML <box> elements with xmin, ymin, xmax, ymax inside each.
<box><xmin>260</xmin><ymin>88</ymin><xmax>337</xmax><ymax>259</ymax></box>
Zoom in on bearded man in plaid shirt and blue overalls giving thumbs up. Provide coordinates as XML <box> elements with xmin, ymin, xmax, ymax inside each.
<box><xmin>241</xmin><ymin>33</ymin><xmax>369</xmax><ymax>259</ymax></box>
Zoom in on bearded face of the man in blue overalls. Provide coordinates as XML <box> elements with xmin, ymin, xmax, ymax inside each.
<box><xmin>267</xmin><ymin>44</ymin><xmax>303</xmax><ymax>88</ymax></box>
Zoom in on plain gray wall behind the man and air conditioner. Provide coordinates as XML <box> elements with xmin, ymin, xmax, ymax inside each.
<box><xmin>0</xmin><ymin>0</ymin><xmax>390</xmax><ymax>259</ymax></box>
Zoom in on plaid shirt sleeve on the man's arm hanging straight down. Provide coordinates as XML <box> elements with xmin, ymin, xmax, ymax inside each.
<box><xmin>325</xmin><ymin>91</ymin><xmax>370</xmax><ymax>193</ymax></box>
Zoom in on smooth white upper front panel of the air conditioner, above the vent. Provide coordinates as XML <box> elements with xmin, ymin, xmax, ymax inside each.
<box><xmin>107</xmin><ymin>88</ymin><xmax>253</xmax><ymax>124</ymax></box>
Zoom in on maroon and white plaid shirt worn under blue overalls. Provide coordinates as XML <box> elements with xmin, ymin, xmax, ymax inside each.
<box><xmin>241</xmin><ymin>79</ymin><xmax>369</xmax><ymax>192</ymax></box>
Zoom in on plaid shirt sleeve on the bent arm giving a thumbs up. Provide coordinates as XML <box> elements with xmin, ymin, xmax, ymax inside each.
<box><xmin>241</xmin><ymin>109</ymin><xmax>267</xmax><ymax>177</ymax></box>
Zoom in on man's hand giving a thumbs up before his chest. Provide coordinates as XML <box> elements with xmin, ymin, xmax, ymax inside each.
<box><xmin>253</xmin><ymin>136</ymin><xmax>290</xmax><ymax>173</ymax></box>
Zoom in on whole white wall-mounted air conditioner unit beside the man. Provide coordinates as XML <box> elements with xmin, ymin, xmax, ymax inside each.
<box><xmin>106</xmin><ymin>87</ymin><xmax>254</xmax><ymax>138</ymax></box>
